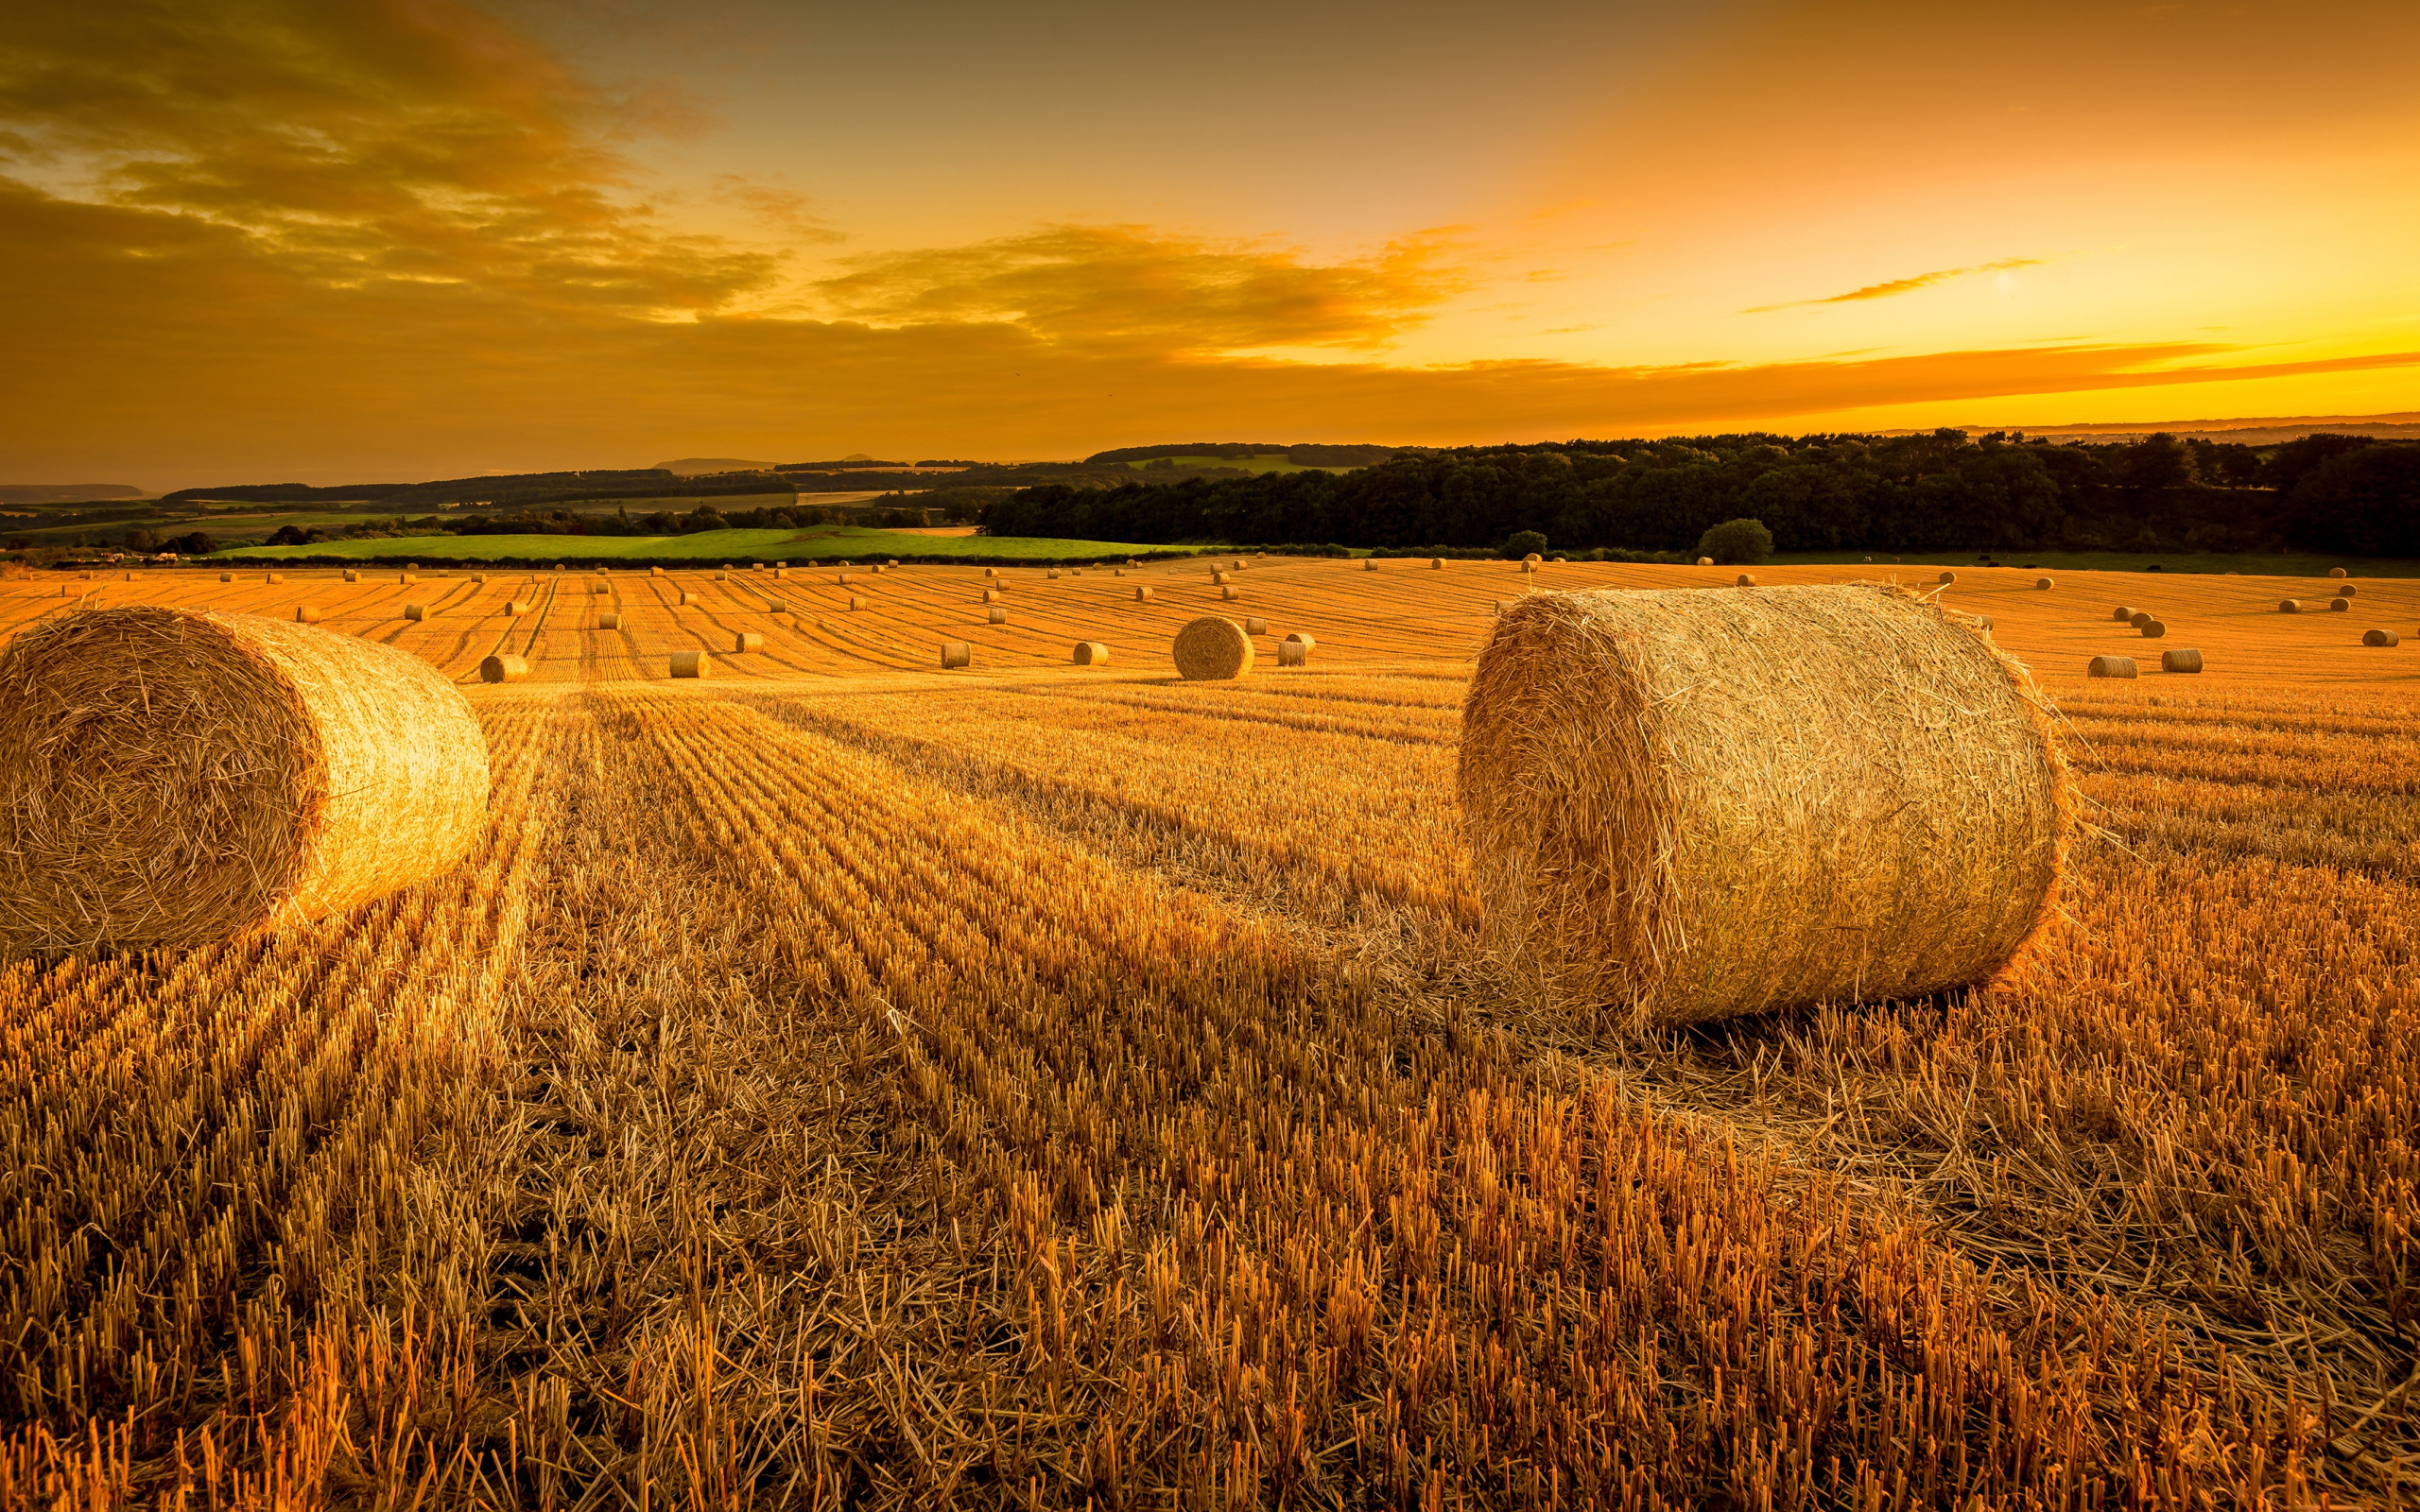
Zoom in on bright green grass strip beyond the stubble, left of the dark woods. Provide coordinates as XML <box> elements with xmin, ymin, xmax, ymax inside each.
<box><xmin>211</xmin><ymin>525</ymin><xmax>1222</xmax><ymax>561</ymax></box>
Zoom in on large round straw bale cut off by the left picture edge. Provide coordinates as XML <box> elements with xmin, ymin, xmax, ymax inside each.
<box><xmin>0</xmin><ymin>608</ymin><xmax>487</xmax><ymax>951</ymax></box>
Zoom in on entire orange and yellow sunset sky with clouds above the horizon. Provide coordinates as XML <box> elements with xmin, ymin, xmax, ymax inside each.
<box><xmin>0</xmin><ymin>0</ymin><xmax>2420</xmax><ymax>489</ymax></box>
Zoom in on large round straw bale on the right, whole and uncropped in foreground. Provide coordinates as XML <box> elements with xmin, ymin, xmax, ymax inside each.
<box><xmin>1460</xmin><ymin>583</ymin><xmax>2074</xmax><ymax>1028</ymax></box>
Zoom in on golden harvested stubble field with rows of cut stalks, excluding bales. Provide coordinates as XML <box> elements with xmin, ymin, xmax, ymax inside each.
<box><xmin>0</xmin><ymin>557</ymin><xmax>2420</xmax><ymax>1509</ymax></box>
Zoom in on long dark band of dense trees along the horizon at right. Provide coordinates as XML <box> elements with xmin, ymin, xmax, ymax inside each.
<box><xmin>982</xmin><ymin>431</ymin><xmax>2420</xmax><ymax>557</ymax></box>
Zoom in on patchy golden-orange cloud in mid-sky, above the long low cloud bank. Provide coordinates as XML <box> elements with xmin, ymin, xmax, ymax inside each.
<box><xmin>816</xmin><ymin>225</ymin><xmax>1469</xmax><ymax>353</ymax></box>
